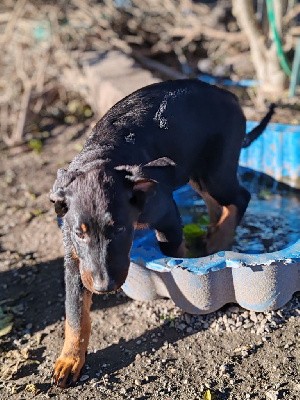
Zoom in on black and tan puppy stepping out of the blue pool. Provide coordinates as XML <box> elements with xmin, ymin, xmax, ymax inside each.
<box><xmin>50</xmin><ymin>80</ymin><xmax>273</xmax><ymax>387</ymax></box>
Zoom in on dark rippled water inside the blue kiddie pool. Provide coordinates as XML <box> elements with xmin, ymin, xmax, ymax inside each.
<box><xmin>175</xmin><ymin>177</ymin><xmax>300</xmax><ymax>257</ymax></box>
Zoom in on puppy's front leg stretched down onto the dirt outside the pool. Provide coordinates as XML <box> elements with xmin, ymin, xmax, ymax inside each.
<box><xmin>53</xmin><ymin>231</ymin><xmax>92</xmax><ymax>387</ymax></box>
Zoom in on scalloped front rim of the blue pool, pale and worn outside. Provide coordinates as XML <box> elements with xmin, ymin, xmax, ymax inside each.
<box><xmin>123</xmin><ymin>239</ymin><xmax>300</xmax><ymax>314</ymax></box>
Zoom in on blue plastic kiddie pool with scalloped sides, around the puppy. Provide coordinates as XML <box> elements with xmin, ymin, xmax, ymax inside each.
<box><xmin>123</xmin><ymin>122</ymin><xmax>300</xmax><ymax>314</ymax></box>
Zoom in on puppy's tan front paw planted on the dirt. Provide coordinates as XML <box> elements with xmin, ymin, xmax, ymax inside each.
<box><xmin>52</xmin><ymin>355</ymin><xmax>85</xmax><ymax>388</ymax></box>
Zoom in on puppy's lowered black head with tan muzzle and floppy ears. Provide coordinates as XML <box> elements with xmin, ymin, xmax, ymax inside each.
<box><xmin>50</xmin><ymin>159</ymin><xmax>176</xmax><ymax>293</ymax></box>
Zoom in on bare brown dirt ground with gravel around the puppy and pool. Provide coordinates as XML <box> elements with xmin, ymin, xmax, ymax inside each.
<box><xmin>0</xmin><ymin>113</ymin><xmax>300</xmax><ymax>400</ymax></box>
